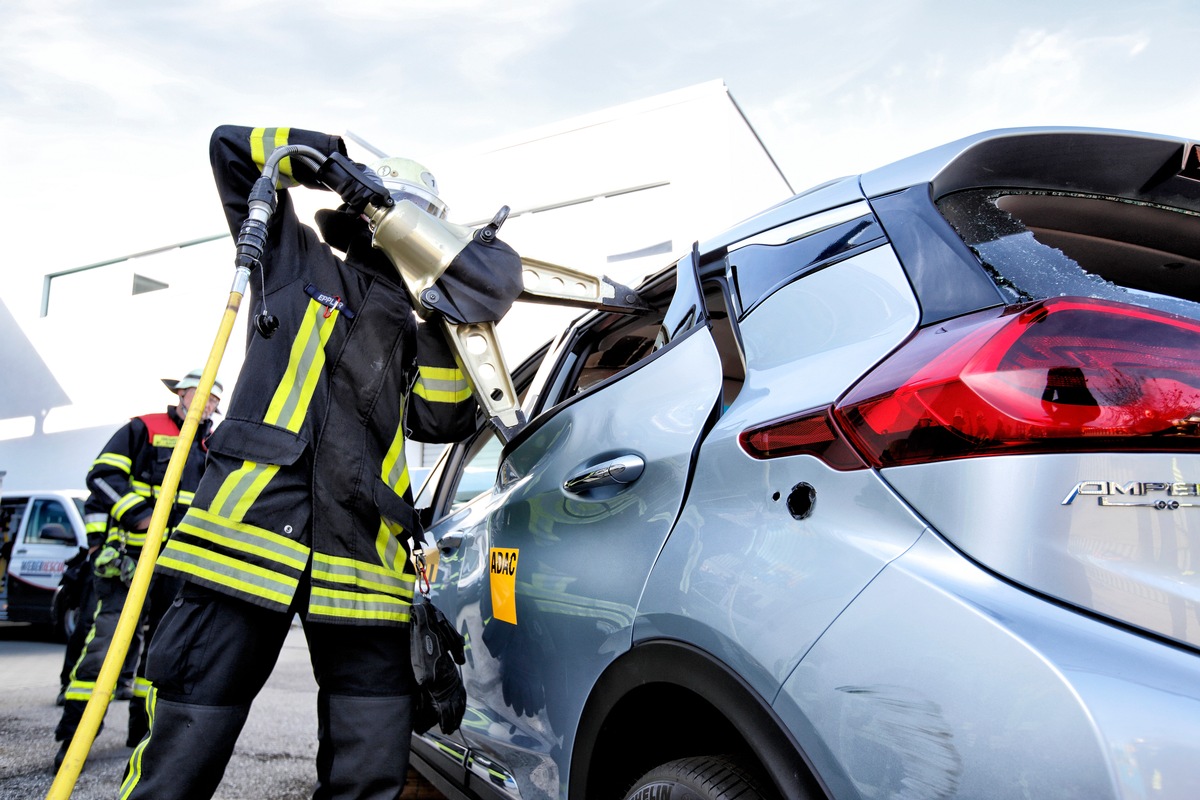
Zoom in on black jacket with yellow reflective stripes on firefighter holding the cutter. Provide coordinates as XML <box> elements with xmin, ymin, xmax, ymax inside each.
<box><xmin>157</xmin><ymin>126</ymin><xmax>475</xmax><ymax>625</ymax></box>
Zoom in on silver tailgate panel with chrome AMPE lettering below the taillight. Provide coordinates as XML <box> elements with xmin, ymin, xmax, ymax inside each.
<box><xmin>883</xmin><ymin>453</ymin><xmax>1200</xmax><ymax>649</ymax></box>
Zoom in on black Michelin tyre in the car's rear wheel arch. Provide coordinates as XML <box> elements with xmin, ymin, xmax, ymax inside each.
<box><xmin>625</xmin><ymin>756</ymin><xmax>774</xmax><ymax>800</ymax></box>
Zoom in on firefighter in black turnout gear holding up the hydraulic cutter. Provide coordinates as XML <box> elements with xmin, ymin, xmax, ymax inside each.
<box><xmin>121</xmin><ymin>126</ymin><xmax>521</xmax><ymax>800</ymax></box>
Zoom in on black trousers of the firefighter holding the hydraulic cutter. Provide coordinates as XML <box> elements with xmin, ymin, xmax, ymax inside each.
<box><xmin>120</xmin><ymin>584</ymin><xmax>414</xmax><ymax>800</ymax></box>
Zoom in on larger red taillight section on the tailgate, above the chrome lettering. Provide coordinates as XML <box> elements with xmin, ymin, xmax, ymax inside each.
<box><xmin>834</xmin><ymin>297</ymin><xmax>1200</xmax><ymax>467</ymax></box>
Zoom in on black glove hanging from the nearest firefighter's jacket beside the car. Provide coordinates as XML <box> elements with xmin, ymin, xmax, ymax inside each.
<box><xmin>412</xmin><ymin>599</ymin><xmax>467</xmax><ymax>734</ymax></box>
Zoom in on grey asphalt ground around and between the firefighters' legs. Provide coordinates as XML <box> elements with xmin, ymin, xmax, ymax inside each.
<box><xmin>0</xmin><ymin>622</ymin><xmax>444</xmax><ymax>800</ymax></box>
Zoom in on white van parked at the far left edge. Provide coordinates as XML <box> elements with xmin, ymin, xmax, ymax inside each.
<box><xmin>0</xmin><ymin>491</ymin><xmax>88</xmax><ymax>636</ymax></box>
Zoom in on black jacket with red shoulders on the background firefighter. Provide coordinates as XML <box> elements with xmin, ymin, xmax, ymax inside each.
<box><xmin>84</xmin><ymin>408</ymin><xmax>212</xmax><ymax>558</ymax></box>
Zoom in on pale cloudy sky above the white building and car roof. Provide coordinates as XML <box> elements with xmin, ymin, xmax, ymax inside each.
<box><xmin>0</xmin><ymin>0</ymin><xmax>1200</xmax><ymax>319</ymax></box>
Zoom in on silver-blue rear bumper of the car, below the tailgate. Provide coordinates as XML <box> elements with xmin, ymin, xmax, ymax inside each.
<box><xmin>776</xmin><ymin>531</ymin><xmax>1200</xmax><ymax>800</ymax></box>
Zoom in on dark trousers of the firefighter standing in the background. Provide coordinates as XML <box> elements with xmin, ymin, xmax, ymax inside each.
<box><xmin>54</xmin><ymin>575</ymin><xmax>182</xmax><ymax>746</ymax></box>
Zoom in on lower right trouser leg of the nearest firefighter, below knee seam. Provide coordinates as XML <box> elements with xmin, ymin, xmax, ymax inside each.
<box><xmin>312</xmin><ymin>692</ymin><xmax>413</xmax><ymax>800</ymax></box>
